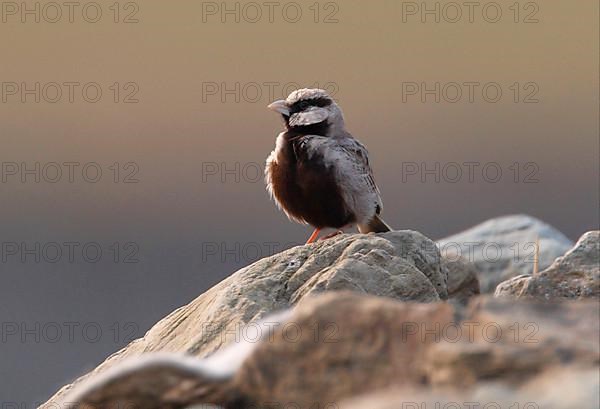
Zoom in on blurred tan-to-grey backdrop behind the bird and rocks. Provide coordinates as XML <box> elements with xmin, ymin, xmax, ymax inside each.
<box><xmin>0</xmin><ymin>0</ymin><xmax>600</xmax><ymax>407</ymax></box>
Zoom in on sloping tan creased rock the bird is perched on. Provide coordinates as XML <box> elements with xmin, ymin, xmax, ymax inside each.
<box><xmin>42</xmin><ymin>231</ymin><xmax>448</xmax><ymax>407</ymax></box>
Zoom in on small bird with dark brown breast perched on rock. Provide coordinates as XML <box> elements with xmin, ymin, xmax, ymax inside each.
<box><xmin>265</xmin><ymin>88</ymin><xmax>391</xmax><ymax>244</ymax></box>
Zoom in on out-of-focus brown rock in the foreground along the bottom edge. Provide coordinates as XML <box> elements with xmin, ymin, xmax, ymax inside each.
<box><xmin>44</xmin><ymin>292</ymin><xmax>600</xmax><ymax>409</ymax></box>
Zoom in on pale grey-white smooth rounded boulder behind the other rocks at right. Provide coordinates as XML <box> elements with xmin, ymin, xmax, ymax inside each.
<box><xmin>438</xmin><ymin>215</ymin><xmax>573</xmax><ymax>293</ymax></box>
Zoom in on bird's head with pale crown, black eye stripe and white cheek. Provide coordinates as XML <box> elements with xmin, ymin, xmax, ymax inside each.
<box><xmin>268</xmin><ymin>88</ymin><xmax>344</xmax><ymax>136</ymax></box>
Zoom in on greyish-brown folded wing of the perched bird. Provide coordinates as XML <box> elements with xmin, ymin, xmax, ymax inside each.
<box><xmin>294</xmin><ymin>135</ymin><xmax>383</xmax><ymax>214</ymax></box>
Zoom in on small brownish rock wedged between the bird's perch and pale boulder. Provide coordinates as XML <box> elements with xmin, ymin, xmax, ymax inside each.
<box><xmin>442</xmin><ymin>257</ymin><xmax>480</xmax><ymax>304</ymax></box>
